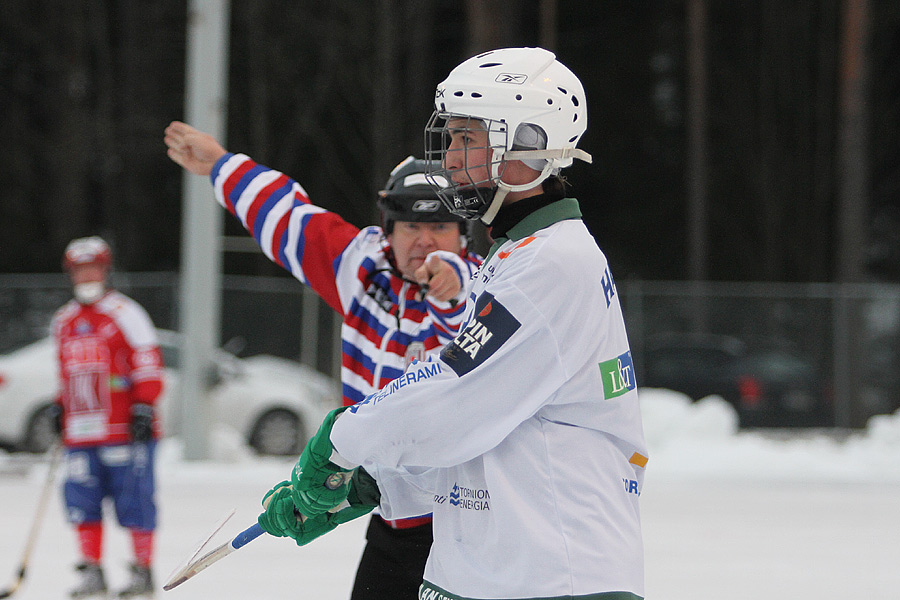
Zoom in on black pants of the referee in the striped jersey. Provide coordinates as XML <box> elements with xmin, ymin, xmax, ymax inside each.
<box><xmin>350</xmin><ymin>515</ymin><xmax>434</xmax><ymax>600</ymax></box>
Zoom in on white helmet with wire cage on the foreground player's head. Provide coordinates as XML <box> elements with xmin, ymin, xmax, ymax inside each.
<box><xmin>425</xmin><ymin>48</ymin><xmax>591</xmax><ymax>224</ymax></box>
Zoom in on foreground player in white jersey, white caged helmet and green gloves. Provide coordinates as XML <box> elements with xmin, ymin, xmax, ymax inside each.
<box><xmin>260</xmin><ymin>48</ymin><xmax>648</xmax><ymax>600</ymax></box>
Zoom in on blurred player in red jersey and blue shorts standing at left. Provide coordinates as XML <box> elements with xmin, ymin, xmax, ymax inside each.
<box><xmin>53</xmin><ymin>236</ymin><xmax>163</xmax><ymax>598</ymax></box>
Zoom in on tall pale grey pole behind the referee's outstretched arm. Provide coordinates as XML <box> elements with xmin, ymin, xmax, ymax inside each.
<box><xmin>177</xmin><ymin>0</ymin><xmax>230</xmax><ymax>460</ymax></box>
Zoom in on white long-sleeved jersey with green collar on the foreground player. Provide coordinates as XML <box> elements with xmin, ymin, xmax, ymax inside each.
<box><xmin>331</xmin><ymin>199</ymin><xmax>647</xmax><ymax>600</ymax></box>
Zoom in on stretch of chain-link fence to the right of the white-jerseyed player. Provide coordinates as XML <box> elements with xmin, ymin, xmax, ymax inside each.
<box><xmin>617</xmin><ymin>281</ymin><xmax>900</xmax><ymax>428</ymax></box>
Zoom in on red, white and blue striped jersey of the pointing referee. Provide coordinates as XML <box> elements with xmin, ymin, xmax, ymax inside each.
<box><xmin>210</xmin><ymin>154</ymin><xmax>481</xmax><ymax>405</ymax></box>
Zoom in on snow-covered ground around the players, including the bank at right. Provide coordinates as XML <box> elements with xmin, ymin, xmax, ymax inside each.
<box><xmin>0</xmin><ymin>390</ymin><xmax>900</xmax><ymax>600</ymax></box>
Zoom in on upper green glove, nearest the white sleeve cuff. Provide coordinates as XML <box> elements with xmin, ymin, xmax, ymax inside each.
<box><xmin>291</xmin><ymin>406</ymin><xmax>350</xmax><ymax>517</ymax></box>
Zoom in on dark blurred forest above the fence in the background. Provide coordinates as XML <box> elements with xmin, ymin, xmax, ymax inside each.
<box><xmin>0</xmin><ymin>0</ymin><xmax>900</xmax><ymax>282</ymax></box>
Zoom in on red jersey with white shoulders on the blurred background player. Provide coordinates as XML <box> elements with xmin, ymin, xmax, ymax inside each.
<box><xmin>53</xmin><ymin>290</ymin><xmax>163</xmax><ymax>447</ymax></box>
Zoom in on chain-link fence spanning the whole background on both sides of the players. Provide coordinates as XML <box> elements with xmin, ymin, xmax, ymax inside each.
<box><xmin>0</xmin><ymin>273</ymin><xmax>900</xmax><ymax>428</ymax></box>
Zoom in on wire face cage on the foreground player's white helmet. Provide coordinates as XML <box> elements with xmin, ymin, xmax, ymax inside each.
<box><xmin>425</xmin><ymin>111</ymin><xmax>508</xmax><ymax>220</ymax></box>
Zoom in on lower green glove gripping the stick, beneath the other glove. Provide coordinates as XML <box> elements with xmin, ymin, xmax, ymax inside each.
<box><xmin>258</xmin><ymin>467</ymin><xmax>380</xmax><ymax>546</ymax></box>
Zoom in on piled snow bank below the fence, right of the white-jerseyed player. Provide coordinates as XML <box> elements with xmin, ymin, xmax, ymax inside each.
<box><xmin>641</xmin><ymin>388</ymin><xmax>900</xmax><ymax>483</ymax></box>
